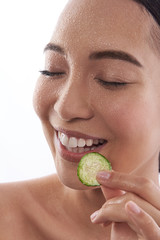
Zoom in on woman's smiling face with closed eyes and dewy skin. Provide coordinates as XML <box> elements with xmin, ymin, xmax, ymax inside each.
<box><xmin>34</xmin><ymin>0</ymin><xmax>160</xmax><ymax>189</ymax></box>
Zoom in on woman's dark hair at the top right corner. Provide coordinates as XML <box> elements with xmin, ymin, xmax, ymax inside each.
<box><xmin>133</xmin><ymin>0</ymin><xmax>160</xmax><ymax>172</ymax></box>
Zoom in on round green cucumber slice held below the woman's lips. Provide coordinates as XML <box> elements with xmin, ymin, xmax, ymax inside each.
<box><xmin>77</xmin><ymin>152</ymin><xmax>112</xmax><ymax>186</ymax></box>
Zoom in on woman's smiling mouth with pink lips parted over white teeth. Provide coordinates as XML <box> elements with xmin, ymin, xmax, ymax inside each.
<box><xmin>56</xmin><ymin>130</ymin><xmax>107</xmax><ymax>162</ymax></box>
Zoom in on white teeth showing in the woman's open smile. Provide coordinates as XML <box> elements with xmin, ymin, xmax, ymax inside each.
<box><xmin>58</xmin><ymin>132</ymin><xmax>105</xmax><ymax>153</ymax></box>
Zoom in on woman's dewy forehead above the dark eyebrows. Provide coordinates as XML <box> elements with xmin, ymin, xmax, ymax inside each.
<box><xmin>51</xmin><ymin>0</ymin><xmax>152</xmax><ymax>61</ymax></box>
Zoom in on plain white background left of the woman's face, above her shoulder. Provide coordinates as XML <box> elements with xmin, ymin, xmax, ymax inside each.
<box><xmin>0</xmin><ymin>0</ymin><xmax>67</xmax><ymax>182</ymax></box>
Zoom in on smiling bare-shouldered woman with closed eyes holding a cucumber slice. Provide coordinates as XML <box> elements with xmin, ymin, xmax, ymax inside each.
<box><xmin>0</xmin><ymin>0</ymin><xmax>160</xmax><ymax>240</ymax></box>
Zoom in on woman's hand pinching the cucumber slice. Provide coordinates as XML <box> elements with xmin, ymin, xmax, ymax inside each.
<box><xmin>91</xmin><ymin>171</ymin><xmax>160</xmax><ymax>240</ymax></box>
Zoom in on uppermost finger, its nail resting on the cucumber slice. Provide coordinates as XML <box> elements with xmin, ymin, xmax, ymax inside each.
<box><xmin>97</xmin><ymin>171</ymin><xmax>160</xmax><ymax>208</ymax></box>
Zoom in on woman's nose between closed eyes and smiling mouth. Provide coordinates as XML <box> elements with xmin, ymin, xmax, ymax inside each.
<box><xmin>54</xmin><ymin>81</ymin><xmax>93</xmax><ymax>121</ymax></box>
